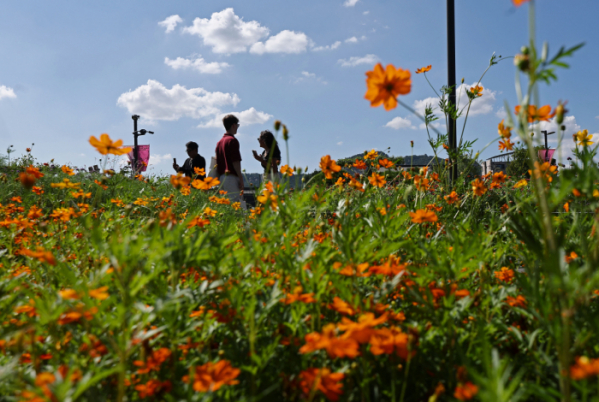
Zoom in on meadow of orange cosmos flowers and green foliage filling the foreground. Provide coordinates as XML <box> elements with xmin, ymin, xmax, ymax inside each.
<box><xmin>0</xmin><ymin>1</ymin><xmax>599</xmax><ymax>402</ymax></box>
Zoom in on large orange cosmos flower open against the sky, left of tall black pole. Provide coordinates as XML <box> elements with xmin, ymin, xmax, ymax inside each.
<box><xmin>364</xmin><ymin>63</ymin><xmax>412</xmax><ymax>110</ymax></box>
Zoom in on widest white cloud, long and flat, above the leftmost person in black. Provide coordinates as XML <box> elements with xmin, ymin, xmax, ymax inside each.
<box><xmin>117</xmin><ymin>80</ymin><xmax>240</xmax><ymax>121</ymax></box>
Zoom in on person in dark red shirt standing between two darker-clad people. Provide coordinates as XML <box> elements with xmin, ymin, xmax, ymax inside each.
<box><xmin>216</xmin><ymin>114</ymin><xmax>243</xmax><ymax>202</ymax></box>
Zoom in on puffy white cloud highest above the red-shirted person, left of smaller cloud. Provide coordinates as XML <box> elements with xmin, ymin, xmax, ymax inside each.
<box><xmin>183</xmin><ymin>8</ymin><xmax>269</xmax><ymax>53</ymax></box>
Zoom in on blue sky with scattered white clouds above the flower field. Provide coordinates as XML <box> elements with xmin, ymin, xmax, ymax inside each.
<box><xmin>0</xmin><ymin>0</ymin><xmax>599</xmax><ymax>173</ymax></box>
